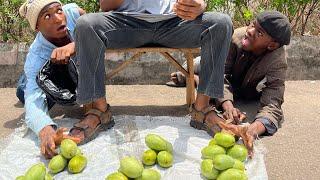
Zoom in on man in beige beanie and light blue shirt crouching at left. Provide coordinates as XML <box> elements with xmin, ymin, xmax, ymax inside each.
<box><xmin>17</xmin><ymin>0</ymin><xmax>84</xmax><ymax>158</ymax></box>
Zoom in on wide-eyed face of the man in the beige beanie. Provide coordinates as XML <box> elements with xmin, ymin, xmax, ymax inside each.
<box><xmin>37</xmin><ymin>3</ymin><xmax>68</xmax><ymax>39</ymax></box>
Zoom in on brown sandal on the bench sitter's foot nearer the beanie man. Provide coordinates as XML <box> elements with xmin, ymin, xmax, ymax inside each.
<box><xmin>69</xmin><ymin>104</ymin><xmax>115</xmax><ymax>145</ymax></box>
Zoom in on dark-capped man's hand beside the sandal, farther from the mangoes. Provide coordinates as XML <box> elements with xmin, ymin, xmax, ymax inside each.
<box><xmin>222</xmin><ymin>101</ymin><xmax>246</xmax><ymax>124</ymax></box>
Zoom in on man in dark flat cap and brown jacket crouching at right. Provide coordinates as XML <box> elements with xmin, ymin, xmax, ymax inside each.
<box><xmin>167</xmin><ymin>11</ymin><xmax>291</xmax><ymax>155</ymax></box>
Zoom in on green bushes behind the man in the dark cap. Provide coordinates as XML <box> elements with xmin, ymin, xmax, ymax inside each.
<box><xmin>206</xmin><ymin>0</ymin><xmax>320</xmax><ymax>35</ymax></box>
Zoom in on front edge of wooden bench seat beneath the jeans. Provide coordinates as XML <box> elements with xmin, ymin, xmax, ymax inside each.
<box><xmin>107</xmin><ymin>47</ymin><xmax>200</xmax><ymax>53</ymax></box>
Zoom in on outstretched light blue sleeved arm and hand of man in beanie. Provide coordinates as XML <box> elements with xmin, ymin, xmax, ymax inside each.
<box><xmin>24</xmin><ymin>52</ymin><xmax>79</xmax><ymax>158</ymax></box>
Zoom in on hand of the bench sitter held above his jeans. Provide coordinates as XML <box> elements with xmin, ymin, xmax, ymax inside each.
<box><xmin>173</xmin><ymin>0</ymin><xmax>206</xmax><ymax>20</ymax></box>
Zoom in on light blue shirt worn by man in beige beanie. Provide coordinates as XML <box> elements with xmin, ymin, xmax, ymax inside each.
<box><xmin>24</xmin><ymin>3</ymin><xmax>80</xmax><ymax>135</ymax></box>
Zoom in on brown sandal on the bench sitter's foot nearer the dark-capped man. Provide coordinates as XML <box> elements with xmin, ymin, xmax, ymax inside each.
<box><xmin>189</xmin><ymin>104</ymin><xmax>225</xmax><ymax>136</ymax></box>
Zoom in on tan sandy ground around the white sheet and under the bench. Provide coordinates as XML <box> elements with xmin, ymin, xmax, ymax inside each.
<box><xmin>0</xmin><ymin>81</ymin><xmax>320</xmax><ymax>180</ymax></box>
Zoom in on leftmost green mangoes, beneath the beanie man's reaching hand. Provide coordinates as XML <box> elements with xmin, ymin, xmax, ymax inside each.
<box><xmin>16</xmin><ymin>139</ymin><xmax>87</xmax><ymax>180</ymax></box>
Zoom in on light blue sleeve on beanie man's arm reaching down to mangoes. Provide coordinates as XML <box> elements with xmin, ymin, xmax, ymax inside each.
<box><xmin>24</xmin><ymin>52</ymin><xmax>56</xmax><ymax>135</ymax></box>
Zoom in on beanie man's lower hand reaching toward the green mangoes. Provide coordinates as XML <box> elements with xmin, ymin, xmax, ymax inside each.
<box><xmin>39</xmin><ymin>125</ymin><xmax>80</xmax><ymax>159</ymax></box>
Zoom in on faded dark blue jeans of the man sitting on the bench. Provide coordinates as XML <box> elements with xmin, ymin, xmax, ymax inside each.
<box><xmin>75</xmin><ymin>12</ymin><xmax>233</xmax><ymax>104</ymax></box>
